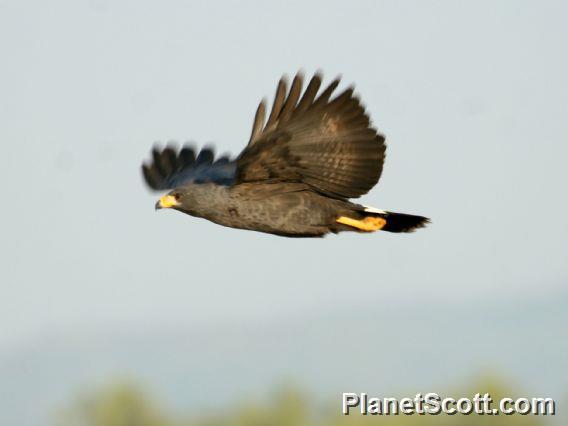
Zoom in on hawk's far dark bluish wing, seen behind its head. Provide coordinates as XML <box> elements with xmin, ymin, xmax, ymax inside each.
<box><xmin>142</xmin><ymin>146</ymin><xmax>236</xmax><ymax>190</ymax></box>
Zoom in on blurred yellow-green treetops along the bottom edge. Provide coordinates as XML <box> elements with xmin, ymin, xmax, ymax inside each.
<box><xmin>54</xmin><ymin>378</ymin><xmax>550</xmax><ymax>426</ymax></box>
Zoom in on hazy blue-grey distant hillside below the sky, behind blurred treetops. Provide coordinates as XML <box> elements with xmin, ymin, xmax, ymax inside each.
<box><xmin>0</xmin><ymin>298</ymin><xmax>568</xmax><ymax>426</ymax></box>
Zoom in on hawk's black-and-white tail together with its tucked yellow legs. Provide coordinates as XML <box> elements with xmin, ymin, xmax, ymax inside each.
<box><xmin>337</xmin><ymin>207</ymin><xmax>430</xmax><ymax>232</ymax></box>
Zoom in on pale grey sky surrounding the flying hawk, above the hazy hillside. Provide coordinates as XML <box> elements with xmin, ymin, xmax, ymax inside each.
<box><xmin>0</xmin><ymin>0</ymin><xmax>568</xmax><ymax>422</ymax></box>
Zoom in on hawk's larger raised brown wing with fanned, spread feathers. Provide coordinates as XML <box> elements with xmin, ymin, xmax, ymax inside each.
<box><xmin>236</xmin><ymin>74</ymin><xmax>386</xmax><ymax>198</ymax></box>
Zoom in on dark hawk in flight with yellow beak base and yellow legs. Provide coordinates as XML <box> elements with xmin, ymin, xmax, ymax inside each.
<box><xmin>142</xmin><ymin>73</ymin><xmax>429</xmax><ymax>237</ymax></box>
